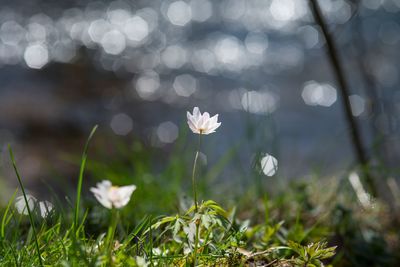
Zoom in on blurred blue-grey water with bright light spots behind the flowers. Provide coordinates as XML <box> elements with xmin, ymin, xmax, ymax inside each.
<box><xmin>0</xmin><ymin>0</ymin><xmax>400</xmax><ymax>199</ymax></box>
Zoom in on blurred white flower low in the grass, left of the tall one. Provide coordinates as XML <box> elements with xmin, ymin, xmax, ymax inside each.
<box><xmin>90</xmin><ymin>180</ymin><xmax>136</xmax><ymax>209</ymax></box>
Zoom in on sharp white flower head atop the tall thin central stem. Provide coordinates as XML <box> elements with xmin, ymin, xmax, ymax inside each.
<box><xmin>187</xmin><ymin>107</ymin><xmax>221</xmax><ymax>134</ymax></box>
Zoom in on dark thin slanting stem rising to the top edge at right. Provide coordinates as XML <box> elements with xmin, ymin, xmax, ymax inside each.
<box><xmin>310</xmin><ymin>0</ymin><xmax>377</xmax><ymax>196</ymax></box>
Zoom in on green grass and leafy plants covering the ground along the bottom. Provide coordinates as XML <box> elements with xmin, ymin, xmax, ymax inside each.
<box><xmin>0</xmin><ymin>128</ymin><xmax>400</xmax><ymax>266</ymax></box>
